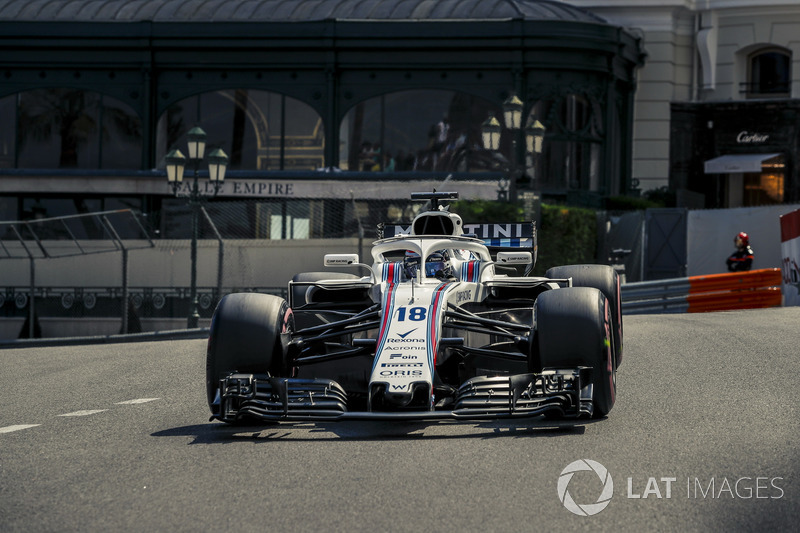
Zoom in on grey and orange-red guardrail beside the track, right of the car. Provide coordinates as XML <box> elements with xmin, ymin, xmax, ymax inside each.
<box><xmin>621</xmin><ymin>268</ymin><xmax>782</xmax><ymax>314</ymax></box>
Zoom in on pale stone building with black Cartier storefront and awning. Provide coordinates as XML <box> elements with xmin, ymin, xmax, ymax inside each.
<box><xmin>566</xmin><ymin>0</ymin><xmax>800</xmax><ymax>207</ymax></box>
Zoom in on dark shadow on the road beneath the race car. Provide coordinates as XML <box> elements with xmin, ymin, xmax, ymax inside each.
<box><xmin>152</xmin><ymin>419</ymin><xmax>601</xmax><ymax>444</ymax></box>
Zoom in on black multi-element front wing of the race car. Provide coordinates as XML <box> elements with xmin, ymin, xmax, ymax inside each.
<box><xmin>212</xmin><ymin>367</ymin><xmax>593</xmax><ymax>422</ymax></box>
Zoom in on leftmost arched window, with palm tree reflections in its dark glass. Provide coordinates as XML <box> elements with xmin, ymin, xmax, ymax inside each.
<box><xmin>8</xmin><ymin>88</ymin><xmax>142</xmax><ymax>169</ymax></box>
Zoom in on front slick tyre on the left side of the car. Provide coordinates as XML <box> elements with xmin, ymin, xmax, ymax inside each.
<box><xmin>206</xmin><ymin>293</ymin><xmax>294</xmax><ymax>415</ymax></box>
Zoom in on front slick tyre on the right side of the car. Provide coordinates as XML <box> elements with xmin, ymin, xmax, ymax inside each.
<box><xmin>535</xmin><ymin>287</ymin><xmax>617</xmax><ymax>418</ymax></box>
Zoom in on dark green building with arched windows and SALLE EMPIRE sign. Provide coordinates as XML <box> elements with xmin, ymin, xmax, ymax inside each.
<box><xmin>0</xmin><ymin>0</ymin><xmax>644</xmax><ymax>237</ymax></box>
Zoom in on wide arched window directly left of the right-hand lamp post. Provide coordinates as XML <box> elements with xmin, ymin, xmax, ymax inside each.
<box><xmin>339</xmin><ymin>90</ymin><xmax>500</xmax><ymax>172</ymax></box>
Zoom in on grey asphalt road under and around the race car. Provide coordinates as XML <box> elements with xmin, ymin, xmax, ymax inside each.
<box><xmin>0</xmin><ymin>308</ymin><xmax>800</xmax><ymax>532</ymax></box>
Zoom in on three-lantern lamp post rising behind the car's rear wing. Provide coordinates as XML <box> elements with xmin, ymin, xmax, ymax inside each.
<box><xmin>481</xmin><ymin>94</ymin><xmax>545</xmax><ymax>199</ymax></box>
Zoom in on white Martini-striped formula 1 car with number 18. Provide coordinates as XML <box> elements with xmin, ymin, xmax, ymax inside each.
<box><xmin>206</xmin><ymin>191</ymin><xmax>622</xmax><ymax>422</ymax></box>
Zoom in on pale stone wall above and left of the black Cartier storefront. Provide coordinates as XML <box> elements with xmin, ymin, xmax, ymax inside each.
<box><xmin>562</xmin><ymin>0</ymin><xmax>800</xmax><ymax>191</ymax></box>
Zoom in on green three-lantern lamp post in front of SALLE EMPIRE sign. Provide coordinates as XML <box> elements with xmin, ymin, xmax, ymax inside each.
<box><xmin>166</xmin><ymin>127</ymin><xmax>228</xmax><ymax>328</ymax></box>
